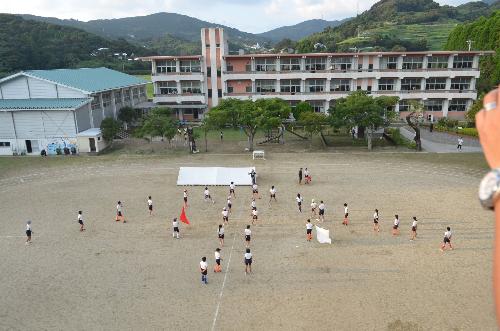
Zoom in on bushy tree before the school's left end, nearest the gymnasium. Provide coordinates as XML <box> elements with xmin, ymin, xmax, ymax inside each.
<box><xmin>140</xmin><ymin>107</ymin><xmax>178</xmax><ymax>144</ymax></box>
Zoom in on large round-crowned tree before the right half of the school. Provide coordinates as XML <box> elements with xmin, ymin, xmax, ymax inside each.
<box><xmin>328</xmin><ymin>91</ymin><xmax>399</xmax><ymax>150</ymax></box>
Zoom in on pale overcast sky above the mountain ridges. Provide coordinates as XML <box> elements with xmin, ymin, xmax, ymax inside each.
<box><xmin>0</xmin><ymin>0</ymin><xmax>469</xmax><ymax>33</ymax></box>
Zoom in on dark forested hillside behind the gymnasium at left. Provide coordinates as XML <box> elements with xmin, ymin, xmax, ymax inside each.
<box><xmin>0</xmin><ymin>14</ymin><xmax>151</xmax><ymax>76</ymax></box>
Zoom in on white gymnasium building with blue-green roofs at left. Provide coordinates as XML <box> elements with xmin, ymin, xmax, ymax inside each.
<box><xmin>0</xmin><ymin>68</ymin><xmax>147</xmax><ymax>155</ymax></box>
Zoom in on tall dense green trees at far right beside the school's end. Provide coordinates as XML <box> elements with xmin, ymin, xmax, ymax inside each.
<box><xmin>445</xmin><ymin>10</ymin><xmax>500</xmax><ymax>92</ymax></box>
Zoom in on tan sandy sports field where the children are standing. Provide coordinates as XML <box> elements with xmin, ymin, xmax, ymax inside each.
<box><xmin>0</xmin><ymin>153</ymin><xmax>495</xmax><ymax>330</ymax></box>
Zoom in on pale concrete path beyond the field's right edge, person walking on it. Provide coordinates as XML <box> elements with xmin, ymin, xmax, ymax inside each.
<box><xmin>399</xmin><ymin>127</ymin><xmax>483</xmax><ymax>153</ymax></box>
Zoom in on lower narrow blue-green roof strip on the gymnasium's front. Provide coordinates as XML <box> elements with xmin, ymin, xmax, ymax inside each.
<box><xmin>0</xmin><ymin>98</ymin><xmax>90</xmax><ymax>111</ymax></box>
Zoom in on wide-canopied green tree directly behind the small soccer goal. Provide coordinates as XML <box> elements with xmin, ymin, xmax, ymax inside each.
<box><xmin>207</xmin><ymin>98</ymin><xmax>291</xmax><ymax>151</ymax></box>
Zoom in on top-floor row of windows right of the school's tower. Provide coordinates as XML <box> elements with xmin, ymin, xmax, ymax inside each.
<box><xmin>225</xmin><ymin>55</ymin><xmax>474</xmax><ymax>71</ymax></box>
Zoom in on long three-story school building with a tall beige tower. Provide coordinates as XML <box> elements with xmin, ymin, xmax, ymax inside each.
<box><xmin>143</xmin><ymin>28</ymin><xmax>493</xmax><ymax>120</ymax></box>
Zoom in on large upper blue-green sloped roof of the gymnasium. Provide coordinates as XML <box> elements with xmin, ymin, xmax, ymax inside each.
<box><xmin>24</xmin><ymin>68</ymin><xmax>148</xmax><ymax>93</ymax></box>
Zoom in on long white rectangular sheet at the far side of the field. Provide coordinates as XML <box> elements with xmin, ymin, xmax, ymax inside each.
<box><xmin>177</xmin><ymin>167</ymin><xmax>255</xmax><ymax>186</ymax></box>
